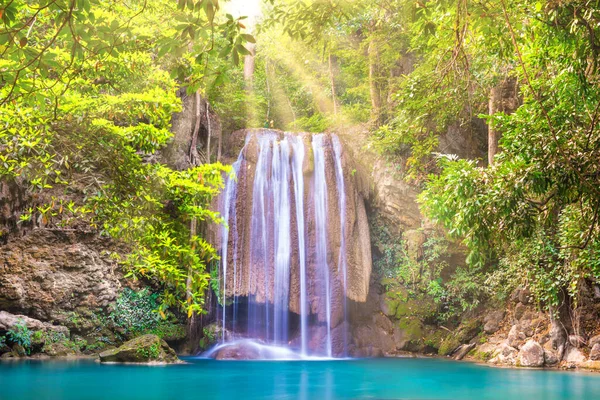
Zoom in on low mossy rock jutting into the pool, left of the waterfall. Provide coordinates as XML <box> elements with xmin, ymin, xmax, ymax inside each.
<box><xmin>100</xmin><ymin>335</ymin><xmax>181</xmax><ymax>364</ymax></box>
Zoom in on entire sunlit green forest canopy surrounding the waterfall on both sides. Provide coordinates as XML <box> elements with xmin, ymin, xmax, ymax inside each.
<box><xmin>0</xmin><ymin>0</ymin><xmax>600</xmax><ymax>320</ymax></box>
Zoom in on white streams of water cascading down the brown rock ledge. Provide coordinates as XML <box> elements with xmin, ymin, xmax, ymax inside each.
<box><xmin>214</xmin><ymin>130</ymin><xmax>348</xmax><ymax>357</ymax></box>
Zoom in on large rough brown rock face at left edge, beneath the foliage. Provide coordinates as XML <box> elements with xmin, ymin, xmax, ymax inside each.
<box><xmin>0</xmin><ymin>229</ymin><xmax>122</xmax><ymax>330</ymax></box>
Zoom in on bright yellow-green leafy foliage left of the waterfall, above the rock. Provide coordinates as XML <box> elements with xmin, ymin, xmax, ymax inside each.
<box><xmin>0</xmin><ymin>0</ymin><xmax>248</xmax><ymax>315</ymax></box>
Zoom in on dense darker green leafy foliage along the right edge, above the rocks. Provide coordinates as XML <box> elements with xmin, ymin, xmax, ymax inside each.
<box><xmin>421</xmin><ymin>3</ymin><xmax>600</xmax><ymax>308</ymax></box>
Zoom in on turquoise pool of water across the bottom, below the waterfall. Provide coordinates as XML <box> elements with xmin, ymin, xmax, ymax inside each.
<box><xmin>0</xmin><ymin>358</ymin><xmax>600</xmax><ymax>400</ymax></box>
